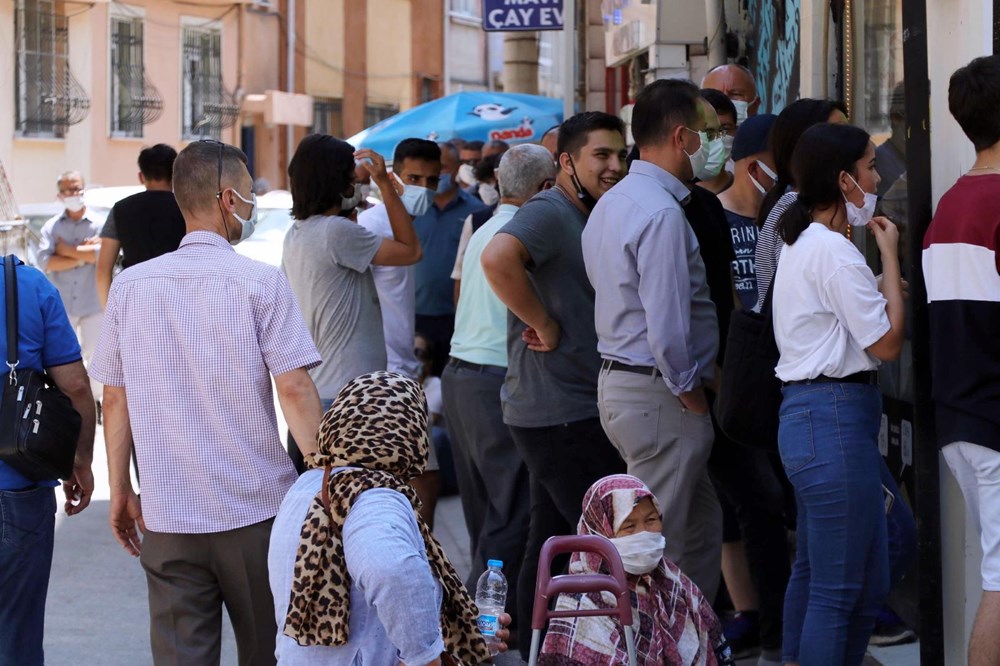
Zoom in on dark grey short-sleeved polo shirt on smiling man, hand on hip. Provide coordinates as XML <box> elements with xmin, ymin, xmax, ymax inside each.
<box><xmin>498</xmin><ymin>190</ymin><xmax>601</xmax><ymax>428</ymax></box>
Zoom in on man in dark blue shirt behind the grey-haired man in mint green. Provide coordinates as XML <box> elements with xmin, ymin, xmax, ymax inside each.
<box><xmin>413</xmin><ymin>143</ymin><xmax>485</xmax><ymax>375</ymax></box>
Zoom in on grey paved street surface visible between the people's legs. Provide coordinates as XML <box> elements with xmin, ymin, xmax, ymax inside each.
<box><xmin>45</xmin><ymin>423</ymin><xmax>918</xmax><ymax>666</ymax></box>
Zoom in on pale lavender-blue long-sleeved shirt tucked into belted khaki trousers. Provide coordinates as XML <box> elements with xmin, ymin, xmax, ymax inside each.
<box><xmin>583</xmin><ymin>160</ymin><xmax>719</xmax><ymax>395</ymax></box>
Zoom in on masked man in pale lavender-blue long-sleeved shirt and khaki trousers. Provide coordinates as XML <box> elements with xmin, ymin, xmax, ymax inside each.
<box><xmin>583</xmin><ymin>80</ymin><xmax>722</xmax><ymax>599</ymax></box>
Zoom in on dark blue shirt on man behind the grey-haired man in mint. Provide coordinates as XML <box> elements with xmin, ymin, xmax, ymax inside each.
<box><xmin>413</xmin><ymin>188</ymin><xmax>485</xmax><ymax>317</ymax></box>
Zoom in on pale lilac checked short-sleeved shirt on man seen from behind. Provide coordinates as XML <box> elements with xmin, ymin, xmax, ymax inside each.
<box><xmin>90</xmin><ymin>231</ymin><xmax>320</xmax><ymax>534</ymax></box>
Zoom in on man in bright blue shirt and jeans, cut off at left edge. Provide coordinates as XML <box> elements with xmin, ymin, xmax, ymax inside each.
<box><xmin>0</xmin><ymin>255</ymin><xmax>96</xmax><ymax>664</ymax></box>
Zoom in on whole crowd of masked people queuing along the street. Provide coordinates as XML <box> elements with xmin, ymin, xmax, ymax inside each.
<box><xmin>0</xmin><ymin>57</ymin><xmax>1000</xmax><ymax>666</ymax></box>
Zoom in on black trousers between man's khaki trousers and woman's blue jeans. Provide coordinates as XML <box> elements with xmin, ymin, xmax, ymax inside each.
<box><xmin>708</xmin><ymin>428</ymin><xmax>791</xmax><ymax>650</ymax></box>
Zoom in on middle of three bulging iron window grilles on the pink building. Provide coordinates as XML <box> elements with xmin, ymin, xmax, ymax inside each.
<box><xmin>109</xmin><ymin>16</ymin><xmax>163</xmax><ymax>137</ymax></box>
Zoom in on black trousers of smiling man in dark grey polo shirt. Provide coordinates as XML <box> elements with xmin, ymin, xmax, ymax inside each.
<box><xmin>510</xmin><ymin>417</ymin><xmax>625</xmax><ymax>654</ymax></box>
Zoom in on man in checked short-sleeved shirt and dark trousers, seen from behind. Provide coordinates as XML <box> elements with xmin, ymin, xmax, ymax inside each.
<box><xmin>91</xmin><ymin>141</ymin><xmax>322</xmax><ymax>665</ymax></box>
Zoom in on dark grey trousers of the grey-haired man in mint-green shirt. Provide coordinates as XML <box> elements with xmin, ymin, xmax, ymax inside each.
<box><xmin>441</xmin><ymin>360</ymin><xmax>529</xmax><ymax>626</ymax></box>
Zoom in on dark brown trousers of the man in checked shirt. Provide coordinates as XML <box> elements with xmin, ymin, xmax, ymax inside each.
<box><xmin>140</xmin><ymin>519</ymin><xmax>277</xmax><ymax>666</ymax></box>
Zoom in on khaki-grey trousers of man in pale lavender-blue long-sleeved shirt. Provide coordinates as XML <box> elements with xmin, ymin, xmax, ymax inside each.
<box><xmin>597</xmin><ymin>369</ymin><xmax>722</xmax><ymax>602</ymax></box>
